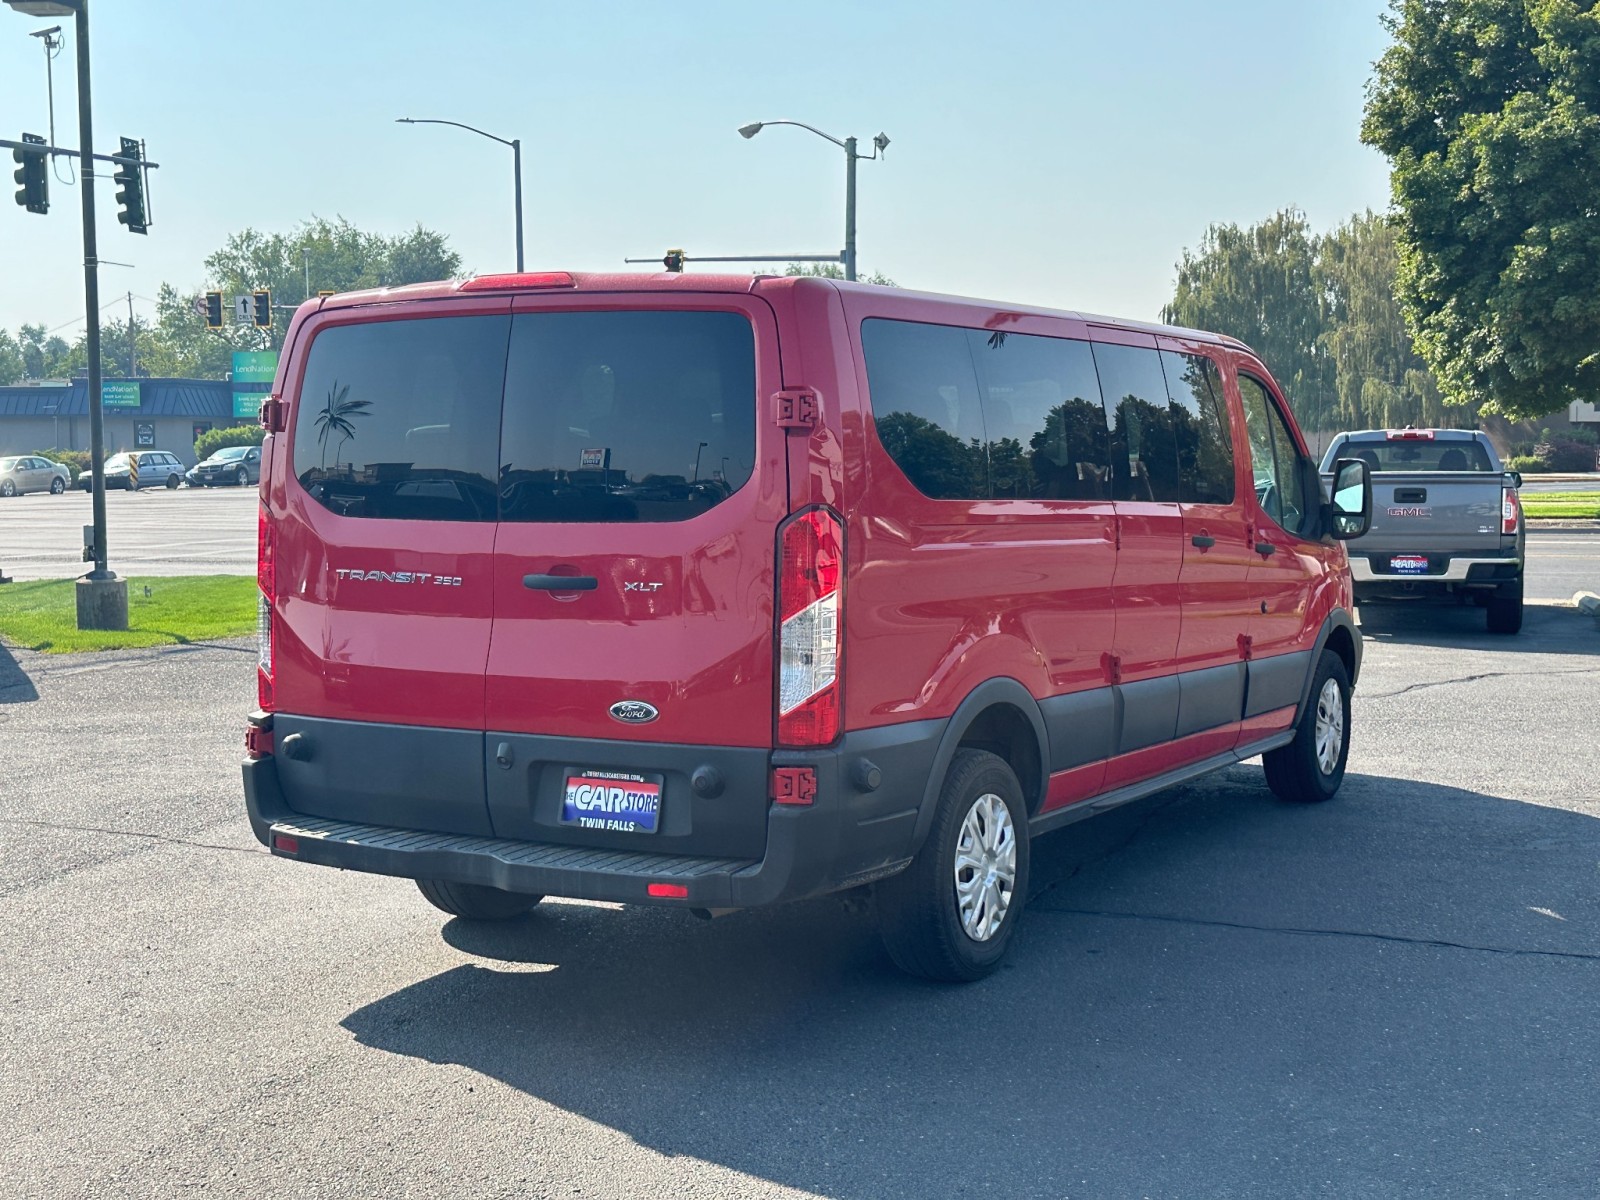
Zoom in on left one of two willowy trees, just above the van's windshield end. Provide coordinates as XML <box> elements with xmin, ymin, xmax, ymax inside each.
<box><xmin>1162</xmin><ymin>208</ymin><xmax>1338</xmax><ymax>430</ymax></box>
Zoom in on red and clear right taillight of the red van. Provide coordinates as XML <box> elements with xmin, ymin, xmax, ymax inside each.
<box><xmin>778</xmin><ymin>509</ymin><xmax>845</xmax><ymax>746</ymax></box>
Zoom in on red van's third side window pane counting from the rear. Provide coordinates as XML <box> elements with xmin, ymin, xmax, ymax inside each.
<box><xmin>1094</xmin><ymin>342</ymin><xmax>1182</xmax><ymax>502</ymax></box>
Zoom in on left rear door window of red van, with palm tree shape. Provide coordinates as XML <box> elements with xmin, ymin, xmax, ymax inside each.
<box><xmin>294</xmin><ymin>317</ymin><xmax>510</xmax><ymax>522</ymax></box>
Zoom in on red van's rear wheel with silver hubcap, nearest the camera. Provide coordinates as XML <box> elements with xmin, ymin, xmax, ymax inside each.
<box><xmin>877</xmin><ymin>750</ymin><xmax>1029</xmax><ymax>982</ymax></box>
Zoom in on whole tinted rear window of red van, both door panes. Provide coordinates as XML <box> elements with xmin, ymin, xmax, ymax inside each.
<box><xmin>294</xmin><ymin>310</ymin><xmax>755</xmax><ymax>522</ymax></box>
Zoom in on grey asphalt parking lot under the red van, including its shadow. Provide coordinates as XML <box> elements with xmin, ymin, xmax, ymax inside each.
<box><xmin>0</xmin><ymin>598</ymin><xmax>1600</xmax><ymax>1200</ymax></box>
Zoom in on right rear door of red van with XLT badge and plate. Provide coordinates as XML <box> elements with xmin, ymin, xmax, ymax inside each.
<box><xmin>486</xmin><ymin>294</ymin><xmax>787</xmax><ymax>858</ymax></box>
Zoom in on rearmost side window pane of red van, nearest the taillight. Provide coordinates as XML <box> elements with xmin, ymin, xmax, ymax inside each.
<box><xmin>861</xmin><ymin>318</ymin><xmax>989</xmax><ymax>499</ymax></box>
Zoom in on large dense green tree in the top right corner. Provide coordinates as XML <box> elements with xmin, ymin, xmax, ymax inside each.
<box><xmin>1362</xmin><ymin>0</ymin><xmax>1600</xmax><ymax>416</ymax></box>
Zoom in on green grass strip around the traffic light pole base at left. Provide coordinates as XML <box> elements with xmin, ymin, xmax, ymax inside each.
<box><xmin>0</xmin><ymin>574</ymin><xmax>256</xmax><ymax>654</ymax></box>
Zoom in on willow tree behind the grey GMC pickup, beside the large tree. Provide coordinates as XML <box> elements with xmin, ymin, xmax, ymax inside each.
<box><xmin>1317</xmin><ymin>211</ymin><xmax>1475</xmax><ymax>429</ymax></box>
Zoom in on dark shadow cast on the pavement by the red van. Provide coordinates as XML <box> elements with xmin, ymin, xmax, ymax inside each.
<box><xmin>344</xmin><ymin>765</ymin><xmax>1600</xmax><ymax>1200</ymax></box>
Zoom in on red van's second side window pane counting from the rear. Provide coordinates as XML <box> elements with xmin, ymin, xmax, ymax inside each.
<box><xmin>968</xmin><ymin>330</ymin><xmax>1110</xmax><ymax>499</ymax></box>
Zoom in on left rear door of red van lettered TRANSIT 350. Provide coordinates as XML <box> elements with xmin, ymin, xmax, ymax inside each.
<box><xmin>273</xmin><ymin>298</ymin><xmax>510</xmax><ymax>834</ymax></box>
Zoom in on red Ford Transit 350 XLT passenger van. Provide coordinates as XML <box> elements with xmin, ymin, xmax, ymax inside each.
<box><xmin>243</xmin><ymin>272</ymin><xmax>1370</xmax><ymax>979</ymax></box>
